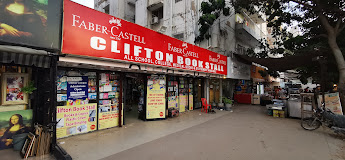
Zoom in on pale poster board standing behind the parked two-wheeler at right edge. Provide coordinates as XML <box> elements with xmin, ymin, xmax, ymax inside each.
<box><xmin>318</xmin><ymin>92</ymin><xmax>343</xmax><ymax>115</ymax></box>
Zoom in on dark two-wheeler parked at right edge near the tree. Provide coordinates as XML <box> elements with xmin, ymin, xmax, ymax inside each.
<box><xmin>301</xmin><ymin>107</ymin><xmax>345</xmax><ymax>135</ymax></box>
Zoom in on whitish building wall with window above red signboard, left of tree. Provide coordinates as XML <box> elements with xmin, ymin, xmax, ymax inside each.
<box><xmin>135</xmin><ymin>0</ymin><xmax>201</xmax><ymax>44</ymax></box>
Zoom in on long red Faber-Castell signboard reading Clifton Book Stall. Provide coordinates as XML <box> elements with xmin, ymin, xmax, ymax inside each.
<box><xmin>62</xmin><ymin>0</ymin><xmax>227</xmax><ymax>75</ymax></box>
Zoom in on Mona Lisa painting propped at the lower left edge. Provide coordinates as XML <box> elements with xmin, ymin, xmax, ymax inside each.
<box><xmin>0</xmin><ymin>109</ymin><xmax>32</xmax><ymax>150</ymax></box>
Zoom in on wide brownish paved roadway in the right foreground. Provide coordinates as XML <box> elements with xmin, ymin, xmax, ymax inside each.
<box><xmin>105</xmin><ymin>105</ymin><xmax>345</xmax><ymax>160</ymax></box>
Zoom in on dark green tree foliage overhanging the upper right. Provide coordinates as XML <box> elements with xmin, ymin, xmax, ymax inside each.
<box><xmin>196</xmin><ymin>0</ymin><xmax>345</xmax><ymax>92</ymax></box>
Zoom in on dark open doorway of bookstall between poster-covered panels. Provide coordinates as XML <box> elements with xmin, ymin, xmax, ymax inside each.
<box><xmin>123</xmin><ymin>73</ymin><xmax>146</xmax><ymax>125</ymax></box>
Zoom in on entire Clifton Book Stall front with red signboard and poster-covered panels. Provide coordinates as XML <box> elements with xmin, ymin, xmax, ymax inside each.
<box><xmin>56</xmin><ymin>0</ymin><xmax>227</xmax><ymax>138</ymax></box>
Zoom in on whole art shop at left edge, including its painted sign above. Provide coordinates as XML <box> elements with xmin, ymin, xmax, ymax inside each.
<box><xmin>0</xmin><ymin>1</ymin><xmax>62</xmax><ymax>157</ymax></box>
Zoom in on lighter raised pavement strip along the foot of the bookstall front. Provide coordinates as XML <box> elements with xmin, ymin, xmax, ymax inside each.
<box><xmin>58</xmin><ymin>109</ymin><xmax>230</xmax><ymax>160</ymax></box>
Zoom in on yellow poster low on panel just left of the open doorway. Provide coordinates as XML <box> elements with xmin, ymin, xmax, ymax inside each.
<box><xmin>98</xmin><ymin>106</ymin><xmax>119</xmax><ymax>129</ymax></box>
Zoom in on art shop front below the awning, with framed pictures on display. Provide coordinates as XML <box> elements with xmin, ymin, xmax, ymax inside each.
<box><xmin>0</xmin><ymin>52</ymin><xmax>57</xmax><ymax>150</ymax></box>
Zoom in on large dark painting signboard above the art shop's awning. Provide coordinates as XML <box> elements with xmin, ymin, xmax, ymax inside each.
<box><xmin>0</xmin><ymin>0</ymin><xmax>62</xmax><ymax>50</ymax></box>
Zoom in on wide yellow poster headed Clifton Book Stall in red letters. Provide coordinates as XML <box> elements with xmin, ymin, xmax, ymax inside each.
<box><xmin>56</xmin><ymin>103</ymin><xmax>97</xmax><ymax>138</ymax></box>
